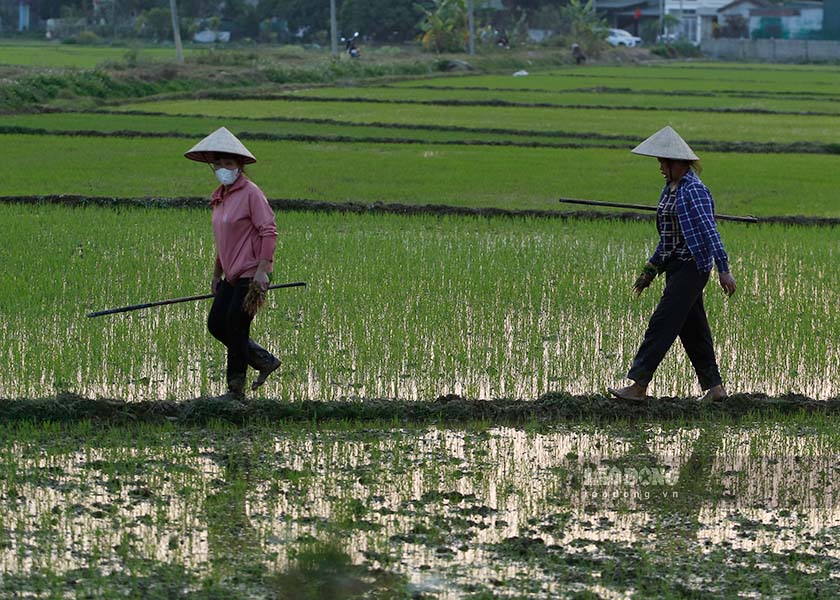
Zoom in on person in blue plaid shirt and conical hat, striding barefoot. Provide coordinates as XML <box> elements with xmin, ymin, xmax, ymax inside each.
<box><xmin>607</xmin><ymin>127</ymin><xmax>736</xmax><ymax>401</ymax></box>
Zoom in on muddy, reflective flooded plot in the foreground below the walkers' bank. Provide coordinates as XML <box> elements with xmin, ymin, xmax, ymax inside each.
<box><xmin>0</xmin><ymin>423</ymin><xmax>840</xmax><ymax>599</ymax></box>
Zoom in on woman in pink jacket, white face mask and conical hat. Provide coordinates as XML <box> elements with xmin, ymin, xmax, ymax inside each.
<box><xmin>184</xmin><ymin>127</ymin><xmax>280</xmax><ymax>397</ymax></box>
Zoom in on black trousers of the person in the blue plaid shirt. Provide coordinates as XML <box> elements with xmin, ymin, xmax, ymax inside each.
<box><xmin>627</xmin><ymin>259</ymin><xmax>721</xmax><ymax>390</ymax></box>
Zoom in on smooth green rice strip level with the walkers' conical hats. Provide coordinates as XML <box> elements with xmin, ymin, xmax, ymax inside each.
<box><xmin>0</xmin><ymin>135</ymin><xmax>840</xmax><ymax>218</ymax></box>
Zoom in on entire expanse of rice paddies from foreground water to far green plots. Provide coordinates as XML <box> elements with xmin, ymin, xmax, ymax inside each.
<box><xmin>0</xmin><ymin>62</ymin><xmax>840</xmax><ymax>600</ymax></box>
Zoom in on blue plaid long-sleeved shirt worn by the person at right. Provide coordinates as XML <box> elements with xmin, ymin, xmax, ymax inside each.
<box><xmin>650</xmin><ymin>170</ymin><xmax>729</xmax><ymax>273</ymax></box>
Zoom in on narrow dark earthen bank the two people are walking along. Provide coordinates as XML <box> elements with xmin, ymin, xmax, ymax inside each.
<box><xmin>0</xmin><ymin>392</ymin><xmax>840</xmax><ymax>424</ymax></box>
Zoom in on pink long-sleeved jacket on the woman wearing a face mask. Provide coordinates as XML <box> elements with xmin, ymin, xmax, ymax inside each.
<box><xmin>210</xmin><ymin>175</ymin><xmax>277</xmax><ymax>281</ymax></box>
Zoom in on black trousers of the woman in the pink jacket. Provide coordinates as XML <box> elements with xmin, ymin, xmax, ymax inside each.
<box><xmin>207</xmin><ymin>278</ymin><xmax>276</xmax><ymax>391</ymax></box>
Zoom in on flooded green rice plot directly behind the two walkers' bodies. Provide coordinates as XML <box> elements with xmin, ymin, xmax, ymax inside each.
<box><xmin>0</xmin><ymin>204</ymin><xmax>840</xmax><ymax>401</ymax></box>
